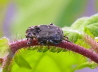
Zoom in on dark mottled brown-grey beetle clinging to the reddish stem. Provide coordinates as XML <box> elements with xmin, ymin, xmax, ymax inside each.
<box><xmin>26</xmin><ymin>23</ymin><xmax>68</xmax><ymax>45</ymax></box>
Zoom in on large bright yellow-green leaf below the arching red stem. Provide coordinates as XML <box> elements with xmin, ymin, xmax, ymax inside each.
<box><xmin>11</xmin><ymin>46</ymin><xmax>86</xmax><ymax>72</ymax></box>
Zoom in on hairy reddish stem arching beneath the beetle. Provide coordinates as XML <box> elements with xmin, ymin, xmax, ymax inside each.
<box><xmin>10</xmin><ymin>40</ymin><xmax>98</xmax><ymax>63</ymax></box>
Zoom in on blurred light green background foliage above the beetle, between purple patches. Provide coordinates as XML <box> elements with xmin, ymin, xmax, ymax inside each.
<box><xmin>12</xmin><ymin>0</ymin><xmax>86</xmax><ymax>37</ymax></box>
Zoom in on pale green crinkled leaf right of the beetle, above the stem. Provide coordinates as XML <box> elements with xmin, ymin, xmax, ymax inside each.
<box><xmin>71</xmin><ymin>14</ymin><xmax>98</xmax><ymax>36</ymax></box>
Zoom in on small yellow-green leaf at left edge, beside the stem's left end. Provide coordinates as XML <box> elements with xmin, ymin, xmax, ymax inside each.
<box><xmin>0</xmin><ymin>37</ymin><xmax>9</xmax><ymax>57</ymax></box>
